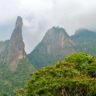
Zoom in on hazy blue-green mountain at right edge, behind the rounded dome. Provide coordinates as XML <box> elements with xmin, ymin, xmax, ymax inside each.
<box><xmin>71</xmin><ymin>29</ymin><xmax>96</xmax><ymax>55</ymax></box>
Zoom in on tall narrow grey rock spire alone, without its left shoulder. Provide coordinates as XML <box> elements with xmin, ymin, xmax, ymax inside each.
<box><xmin>5</xmin><ymin>16</ymin><xmax>26</xmax><ymax>70</ymax></box>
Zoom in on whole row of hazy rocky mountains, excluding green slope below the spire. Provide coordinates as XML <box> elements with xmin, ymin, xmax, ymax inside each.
<box><xmin>0</xmin><ymin>16</ymin><xmax>96</xmax><ymax>71</ymax></box>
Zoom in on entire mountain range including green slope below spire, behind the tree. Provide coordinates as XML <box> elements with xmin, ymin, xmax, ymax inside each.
<box><xmin>0</xmin><ymin>16</ymin><xmax>96</xmax><ymax>96</ymax></box>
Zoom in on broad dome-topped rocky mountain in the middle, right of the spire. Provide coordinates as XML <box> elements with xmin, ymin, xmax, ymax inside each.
<box><xmin>28</xmin><ymin>27</ymin><xmax>74</xmax><ymax>68</ymax></box>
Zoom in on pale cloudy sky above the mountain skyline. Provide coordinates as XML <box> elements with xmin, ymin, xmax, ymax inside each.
<box><xmin>0</xmin><ymin>0</ymin><xmax>96</xmax><ymax>53</ymax></box>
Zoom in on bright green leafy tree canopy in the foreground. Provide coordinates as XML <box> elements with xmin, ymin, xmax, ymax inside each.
<box><xmin>15</xmin><ymin>52</ymin><xmax>96</xmax><ymax>96</ymax></box>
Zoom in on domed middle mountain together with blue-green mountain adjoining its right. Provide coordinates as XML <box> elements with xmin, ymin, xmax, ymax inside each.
<box><xmin>28</xmin><ymin>27</ymin><xmax>96</xmax><ymax>68</ymax></box>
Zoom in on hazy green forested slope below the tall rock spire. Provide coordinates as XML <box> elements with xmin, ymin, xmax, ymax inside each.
<box><xmin>0</xmin><ymin>59</ymin><xmax>35</xmax><ymax>96</ymax></box>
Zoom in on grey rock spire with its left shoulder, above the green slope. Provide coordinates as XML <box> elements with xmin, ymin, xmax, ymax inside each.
<box><xmin>0</xmin><ymin>16</ymin><xmax>26</xmax><ymax>71</ymax></box>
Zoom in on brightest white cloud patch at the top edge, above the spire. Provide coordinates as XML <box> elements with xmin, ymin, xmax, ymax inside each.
<box><xmin>17</xmin><ymin>0</ymin><xmax>52</xmax><ymax>13</ymax></box>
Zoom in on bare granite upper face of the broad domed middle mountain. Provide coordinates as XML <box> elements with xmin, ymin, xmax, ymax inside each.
<box><xmin>42</xmin><ymin>27</ymin><xmax>74</xmax><ymax>55</ymax></box>
